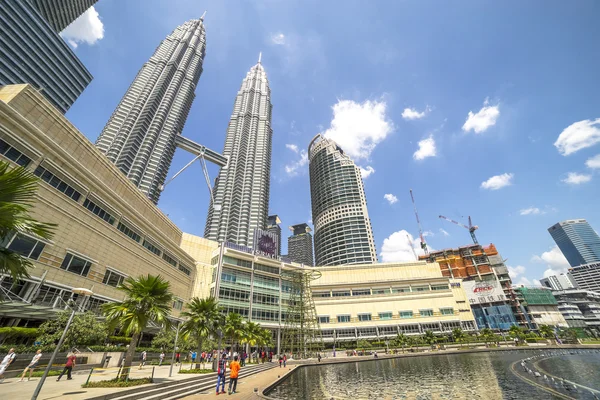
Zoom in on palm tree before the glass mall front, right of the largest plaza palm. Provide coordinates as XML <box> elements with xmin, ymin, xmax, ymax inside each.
<box><xmin>181</xmin><ymin>297</ymin><xmax>223</xmax><ymax>368</ymax></box>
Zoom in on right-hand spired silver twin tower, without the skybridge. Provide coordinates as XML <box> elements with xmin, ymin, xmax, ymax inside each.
<box><xmin>204</xmin><ymin>56</ymin><xmax>273</xmax><ymax>247</ymax></box>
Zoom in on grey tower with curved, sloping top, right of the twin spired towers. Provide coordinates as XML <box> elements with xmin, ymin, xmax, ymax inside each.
<box><xmin>308</xmin><ymin>134</ymin><xmax>377</xmax><ymax>266</ymax></box>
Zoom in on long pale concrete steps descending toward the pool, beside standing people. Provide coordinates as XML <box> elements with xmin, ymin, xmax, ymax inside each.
<box><xmin>88</xmin><ymin>363</ymin><xmax>276</xmax><ymax>400</ymax></box>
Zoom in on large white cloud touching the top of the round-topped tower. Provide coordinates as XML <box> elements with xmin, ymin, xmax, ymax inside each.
<box><xmin>323</xmin><ymin>100</ymin><xmax>394</xmax><ymax>161</ymax></box>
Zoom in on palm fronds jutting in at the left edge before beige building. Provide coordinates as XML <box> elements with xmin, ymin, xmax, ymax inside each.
<box><xmin>0</xmin><ymin>161</ymin><xmax>56</xmax><ymax>281</ymax></box>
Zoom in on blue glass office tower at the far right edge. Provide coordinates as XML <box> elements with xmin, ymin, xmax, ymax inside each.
<box><xmin>548</xmin><ymin>219</ymin><xmax>600</xmax><ymax>267</ymax></box>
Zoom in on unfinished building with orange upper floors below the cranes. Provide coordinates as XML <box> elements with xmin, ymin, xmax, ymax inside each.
<box><xmin>419</xmin><ymin>244</ymin><xmax>529</xmax><ymax>330</ymax></box>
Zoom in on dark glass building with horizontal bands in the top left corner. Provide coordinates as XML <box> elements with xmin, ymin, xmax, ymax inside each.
<box><xmin>0</xmin><ymin>0</ymin><xmax>92</xmax><ymax>114</ymax></box>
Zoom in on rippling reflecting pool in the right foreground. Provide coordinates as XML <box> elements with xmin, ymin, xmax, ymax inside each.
<box><xmin>267</xmin><ymin>350</ymin><xmax>600</xmax><ymax>400</ymax></box>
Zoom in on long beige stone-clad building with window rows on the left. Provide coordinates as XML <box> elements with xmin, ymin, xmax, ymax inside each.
<box><xmin>0</xmin><ymin>85</ymin><xmax>196</xmax><ymax>326</ymax></box>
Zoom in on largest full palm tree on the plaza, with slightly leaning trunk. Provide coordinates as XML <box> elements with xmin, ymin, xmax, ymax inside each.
<box><xmin>102</xmin><ymin>275</ymin><xmax>173</xmax><ymax>379</ymax></box>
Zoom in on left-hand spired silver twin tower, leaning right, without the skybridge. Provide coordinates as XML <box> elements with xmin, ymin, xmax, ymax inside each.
<box><xmin>96</xmin><ymin>17</ymin><xmax>206</xmax><ymax>203</ymax></box>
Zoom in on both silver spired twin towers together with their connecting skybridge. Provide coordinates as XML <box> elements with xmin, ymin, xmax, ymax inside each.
<box><xmin>96</xmin><ymin>16</ymin><xmax>273</xmax><ymax>246</ymax></box>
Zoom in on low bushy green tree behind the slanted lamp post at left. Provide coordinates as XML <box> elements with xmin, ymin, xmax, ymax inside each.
<box><xmin>37</xmin><ymin>310</ymin><xmax>108</xmax><ymax>349</ymax></box>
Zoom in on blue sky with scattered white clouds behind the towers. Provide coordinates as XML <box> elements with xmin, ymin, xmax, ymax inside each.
<box><xmin>63</xmin><ymin>0</ymin><xmax>600</xmax><ymax>284</ymax></box>
